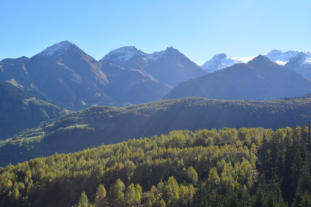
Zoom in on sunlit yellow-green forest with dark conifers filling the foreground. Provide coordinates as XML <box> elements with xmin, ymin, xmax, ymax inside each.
<box><xmin>0</xmin><ymin>127</ymin><xmax>311</xmax><ymax>207</ymax></box>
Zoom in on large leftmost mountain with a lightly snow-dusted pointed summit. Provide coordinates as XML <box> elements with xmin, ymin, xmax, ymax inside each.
<box><xmin>0</xmin><ymin>41</ymin><xmax>114</xmax><ymax>109</ymax></box>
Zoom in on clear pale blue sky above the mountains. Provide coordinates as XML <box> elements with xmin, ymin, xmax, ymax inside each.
<box><xmin>0</xmin><ymin>0</ymin><xmax>311</xmax><ymax>64</ymax></box>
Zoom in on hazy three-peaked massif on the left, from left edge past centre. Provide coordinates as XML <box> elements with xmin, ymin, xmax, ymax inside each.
<box><xmin>0</xmin><ymin>41</ymin><xmax>205</xmax><ymax>110</ymax></box>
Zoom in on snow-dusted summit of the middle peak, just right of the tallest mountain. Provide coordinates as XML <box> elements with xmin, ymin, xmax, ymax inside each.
<box><xmin>101</xmin><ymin>46</ymin><xmax>145</xmax><ymax>62</ymax></box>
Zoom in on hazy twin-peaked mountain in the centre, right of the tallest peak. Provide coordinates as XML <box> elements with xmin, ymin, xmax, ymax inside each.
<box><xmin>101</xmin><ymin>47</ymin><xmax>205</xmax><ymax>87</ymax></box>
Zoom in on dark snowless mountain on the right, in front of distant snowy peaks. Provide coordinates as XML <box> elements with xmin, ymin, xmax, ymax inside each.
<box><xmin>166</xmin><ymin>55</ymin><xmax>311</xmax><ymax>100</ymax></box>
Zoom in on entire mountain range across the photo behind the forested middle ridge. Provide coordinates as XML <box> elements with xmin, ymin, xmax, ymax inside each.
<box><xmin>0</xmin><ymin>41</ymin><xmax>311</xmax><ymax>142</ymax></box>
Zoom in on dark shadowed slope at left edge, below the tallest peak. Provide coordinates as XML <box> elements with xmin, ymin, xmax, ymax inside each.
<box><xmin>0</xmin><ymin>81</ymin><xmax>64</xmax><ymax>139</ymax></box>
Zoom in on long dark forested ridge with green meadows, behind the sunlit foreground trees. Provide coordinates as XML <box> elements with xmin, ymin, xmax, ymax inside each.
<box><xmin>0</xmin><ymin>97</ymin><xmax>311</xmax><ymax>166</ymax></box>
